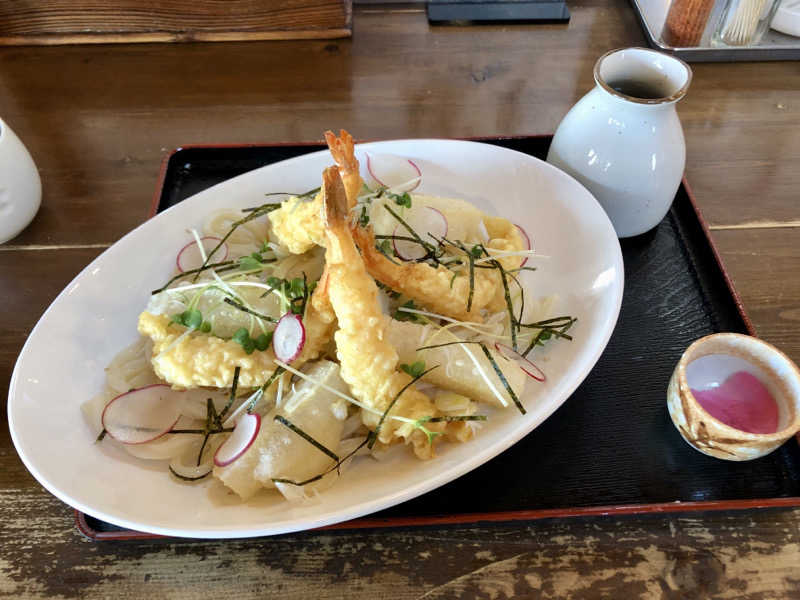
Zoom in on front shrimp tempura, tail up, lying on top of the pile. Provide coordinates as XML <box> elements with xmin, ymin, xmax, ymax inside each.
<box><xmin>323</xmin><ymin>167</ymin><xmax>468</xmax><ymax>458</ymax></box>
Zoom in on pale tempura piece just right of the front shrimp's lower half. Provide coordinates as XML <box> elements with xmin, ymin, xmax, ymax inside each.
<box><xmin>386</xmin><ymin>319</ymin><xmax>527</xmax><ymax>406</ymax></box>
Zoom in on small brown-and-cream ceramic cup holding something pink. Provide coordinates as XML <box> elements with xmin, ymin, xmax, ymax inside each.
<box><xmin>667</xmin><ymin>333</ymin><xmax>800</xmax><ymax>461</ymax></box>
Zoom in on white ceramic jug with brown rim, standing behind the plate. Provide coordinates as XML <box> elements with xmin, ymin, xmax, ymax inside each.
<box><xmin>547</xmin><ymin>48</ymin><xmax>692</xmax><ymax>237</ymax></box>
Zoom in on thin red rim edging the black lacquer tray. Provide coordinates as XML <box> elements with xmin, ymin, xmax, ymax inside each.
<box><xmin>81</xmin><ymin>134</ymin><xmax>780</xmax><ymax>541</ymax></box>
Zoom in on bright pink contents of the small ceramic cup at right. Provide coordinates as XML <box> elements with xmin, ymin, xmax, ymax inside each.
<box><xmin>692</xmin><ymin>371</ymin><xmax>778</xmax><ymax>433</ymax></box>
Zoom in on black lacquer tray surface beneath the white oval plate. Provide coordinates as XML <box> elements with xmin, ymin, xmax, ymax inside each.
<box><xmin>77</xmin><ymin>136</ymin><xmax>800</xmax><ymax>539</ymax></box>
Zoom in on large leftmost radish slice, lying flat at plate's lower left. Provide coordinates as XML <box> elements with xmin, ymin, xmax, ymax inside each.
<box><xmin>102</xmin><ymin>383</ymin><xmax>186</xmax><ymax>444</ymax></box>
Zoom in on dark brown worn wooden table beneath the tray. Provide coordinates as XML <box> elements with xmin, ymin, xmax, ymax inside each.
<box><xmin>0</xmin><ymin>0</ymin><xmax>800</xmax><ymax>599</ymax></box>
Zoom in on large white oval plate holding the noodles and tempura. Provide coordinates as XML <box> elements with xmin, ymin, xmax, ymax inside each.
<box><xmin>8</xmin><ymin>140</ymin><xmax>623</xmax><ymax>538</ymax></box>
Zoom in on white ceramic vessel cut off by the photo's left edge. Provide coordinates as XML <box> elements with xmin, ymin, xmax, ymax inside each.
<box><xmin>0</xmin><ymin>119</ymin><xmax>42</xmax><ymax>244</ymax></box>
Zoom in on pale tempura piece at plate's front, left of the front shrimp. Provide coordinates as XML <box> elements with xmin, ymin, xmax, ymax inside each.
<box><xmin>214</xmin><ymin>360</ymin><xmax>347</xmax><ymax>500</ymax></box>
